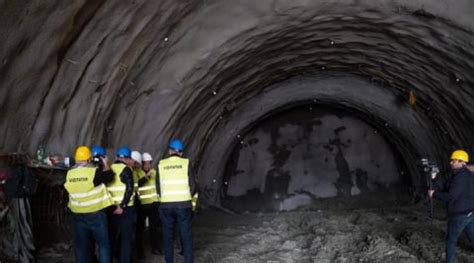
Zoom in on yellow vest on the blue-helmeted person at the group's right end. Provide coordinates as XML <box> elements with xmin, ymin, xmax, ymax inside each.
<box><xmin>158</xmin><ymin>156</ymin><xmax>192</xmax><ymax>203</ymax></box>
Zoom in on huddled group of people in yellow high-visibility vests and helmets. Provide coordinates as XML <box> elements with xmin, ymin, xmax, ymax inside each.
<box><xmin>64</xmin><ymin>139</ymin><xmax>197</xmax><ymax>263</ymax></box>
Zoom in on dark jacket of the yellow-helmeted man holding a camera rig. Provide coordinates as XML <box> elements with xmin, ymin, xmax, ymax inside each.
<box><xmin>434</xmin><ymin>166</ymin><xmax>474</xmax><ymax>216</ymax></box>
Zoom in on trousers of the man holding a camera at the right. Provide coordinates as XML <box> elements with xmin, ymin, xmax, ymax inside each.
<box><xmin>446</xmin><ymin>212</ymin><xmax>474</xmax><ymax>263</ymax></box>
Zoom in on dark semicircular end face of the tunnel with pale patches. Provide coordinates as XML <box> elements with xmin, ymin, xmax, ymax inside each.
<box><xmin>221</xmin><ymin>104</ymin><xmax>414</xmax><ymax>212</ymax></box>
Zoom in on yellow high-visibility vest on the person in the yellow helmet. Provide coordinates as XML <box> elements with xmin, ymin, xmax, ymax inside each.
<box><xmin>64</xmin><ymin>167</ymin><xmax>113</xmax><ymax>214</ymax></box>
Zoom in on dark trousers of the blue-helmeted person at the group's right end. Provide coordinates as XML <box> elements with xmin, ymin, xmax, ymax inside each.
<box><xmin>160</xmin><ymin>207</ymin><xmax>193</xmax><ymax>263</ymax></box>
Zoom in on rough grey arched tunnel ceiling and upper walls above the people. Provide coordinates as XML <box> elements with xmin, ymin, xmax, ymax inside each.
<box><xmin>0</xmin><ymin>0</ymin><xmax>474</xmax><ymax>192</ymax></box>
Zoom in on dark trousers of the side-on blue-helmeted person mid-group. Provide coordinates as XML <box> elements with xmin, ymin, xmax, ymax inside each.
<box><xmin>109</xmin><ymin>207</ymin><xmax>137</xmax><ymax>263</ymax></box>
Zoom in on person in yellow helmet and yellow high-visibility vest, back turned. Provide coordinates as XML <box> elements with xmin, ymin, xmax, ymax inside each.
<box><xmin>64</xmin><ymin>146</ymin><xmax>114</xmax><ymax>263</ymax></box>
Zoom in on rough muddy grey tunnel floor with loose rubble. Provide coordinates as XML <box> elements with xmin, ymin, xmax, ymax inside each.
<box><xmin>38</xmin><ymin>202</ymin><xmax>474</xmax><ymax>262</ymax></box>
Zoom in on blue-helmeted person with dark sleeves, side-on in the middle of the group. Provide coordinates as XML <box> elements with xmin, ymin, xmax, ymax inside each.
<box><xmin>107</xmin><ymin>147</ymin><xmax>136</xmax><ymax>263</ymax></box>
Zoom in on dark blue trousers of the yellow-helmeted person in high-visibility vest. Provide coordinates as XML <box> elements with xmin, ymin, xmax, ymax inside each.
<box><xmin>72</xmin><ymin>212</ymin><xmax>111</xmax><ymax>263</ymax></box>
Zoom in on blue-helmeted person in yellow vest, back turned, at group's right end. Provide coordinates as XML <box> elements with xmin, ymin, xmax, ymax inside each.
<box><xmin>156</xmin><ymin>139</ymin><xmax>196</xmax><ymax>263</ymax></box>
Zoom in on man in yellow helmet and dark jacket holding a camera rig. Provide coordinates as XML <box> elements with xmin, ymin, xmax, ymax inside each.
<box><xmin>428</xmin><ymin>150</ymin><xmax>474</xmax><ymax>263</ymax></box>
